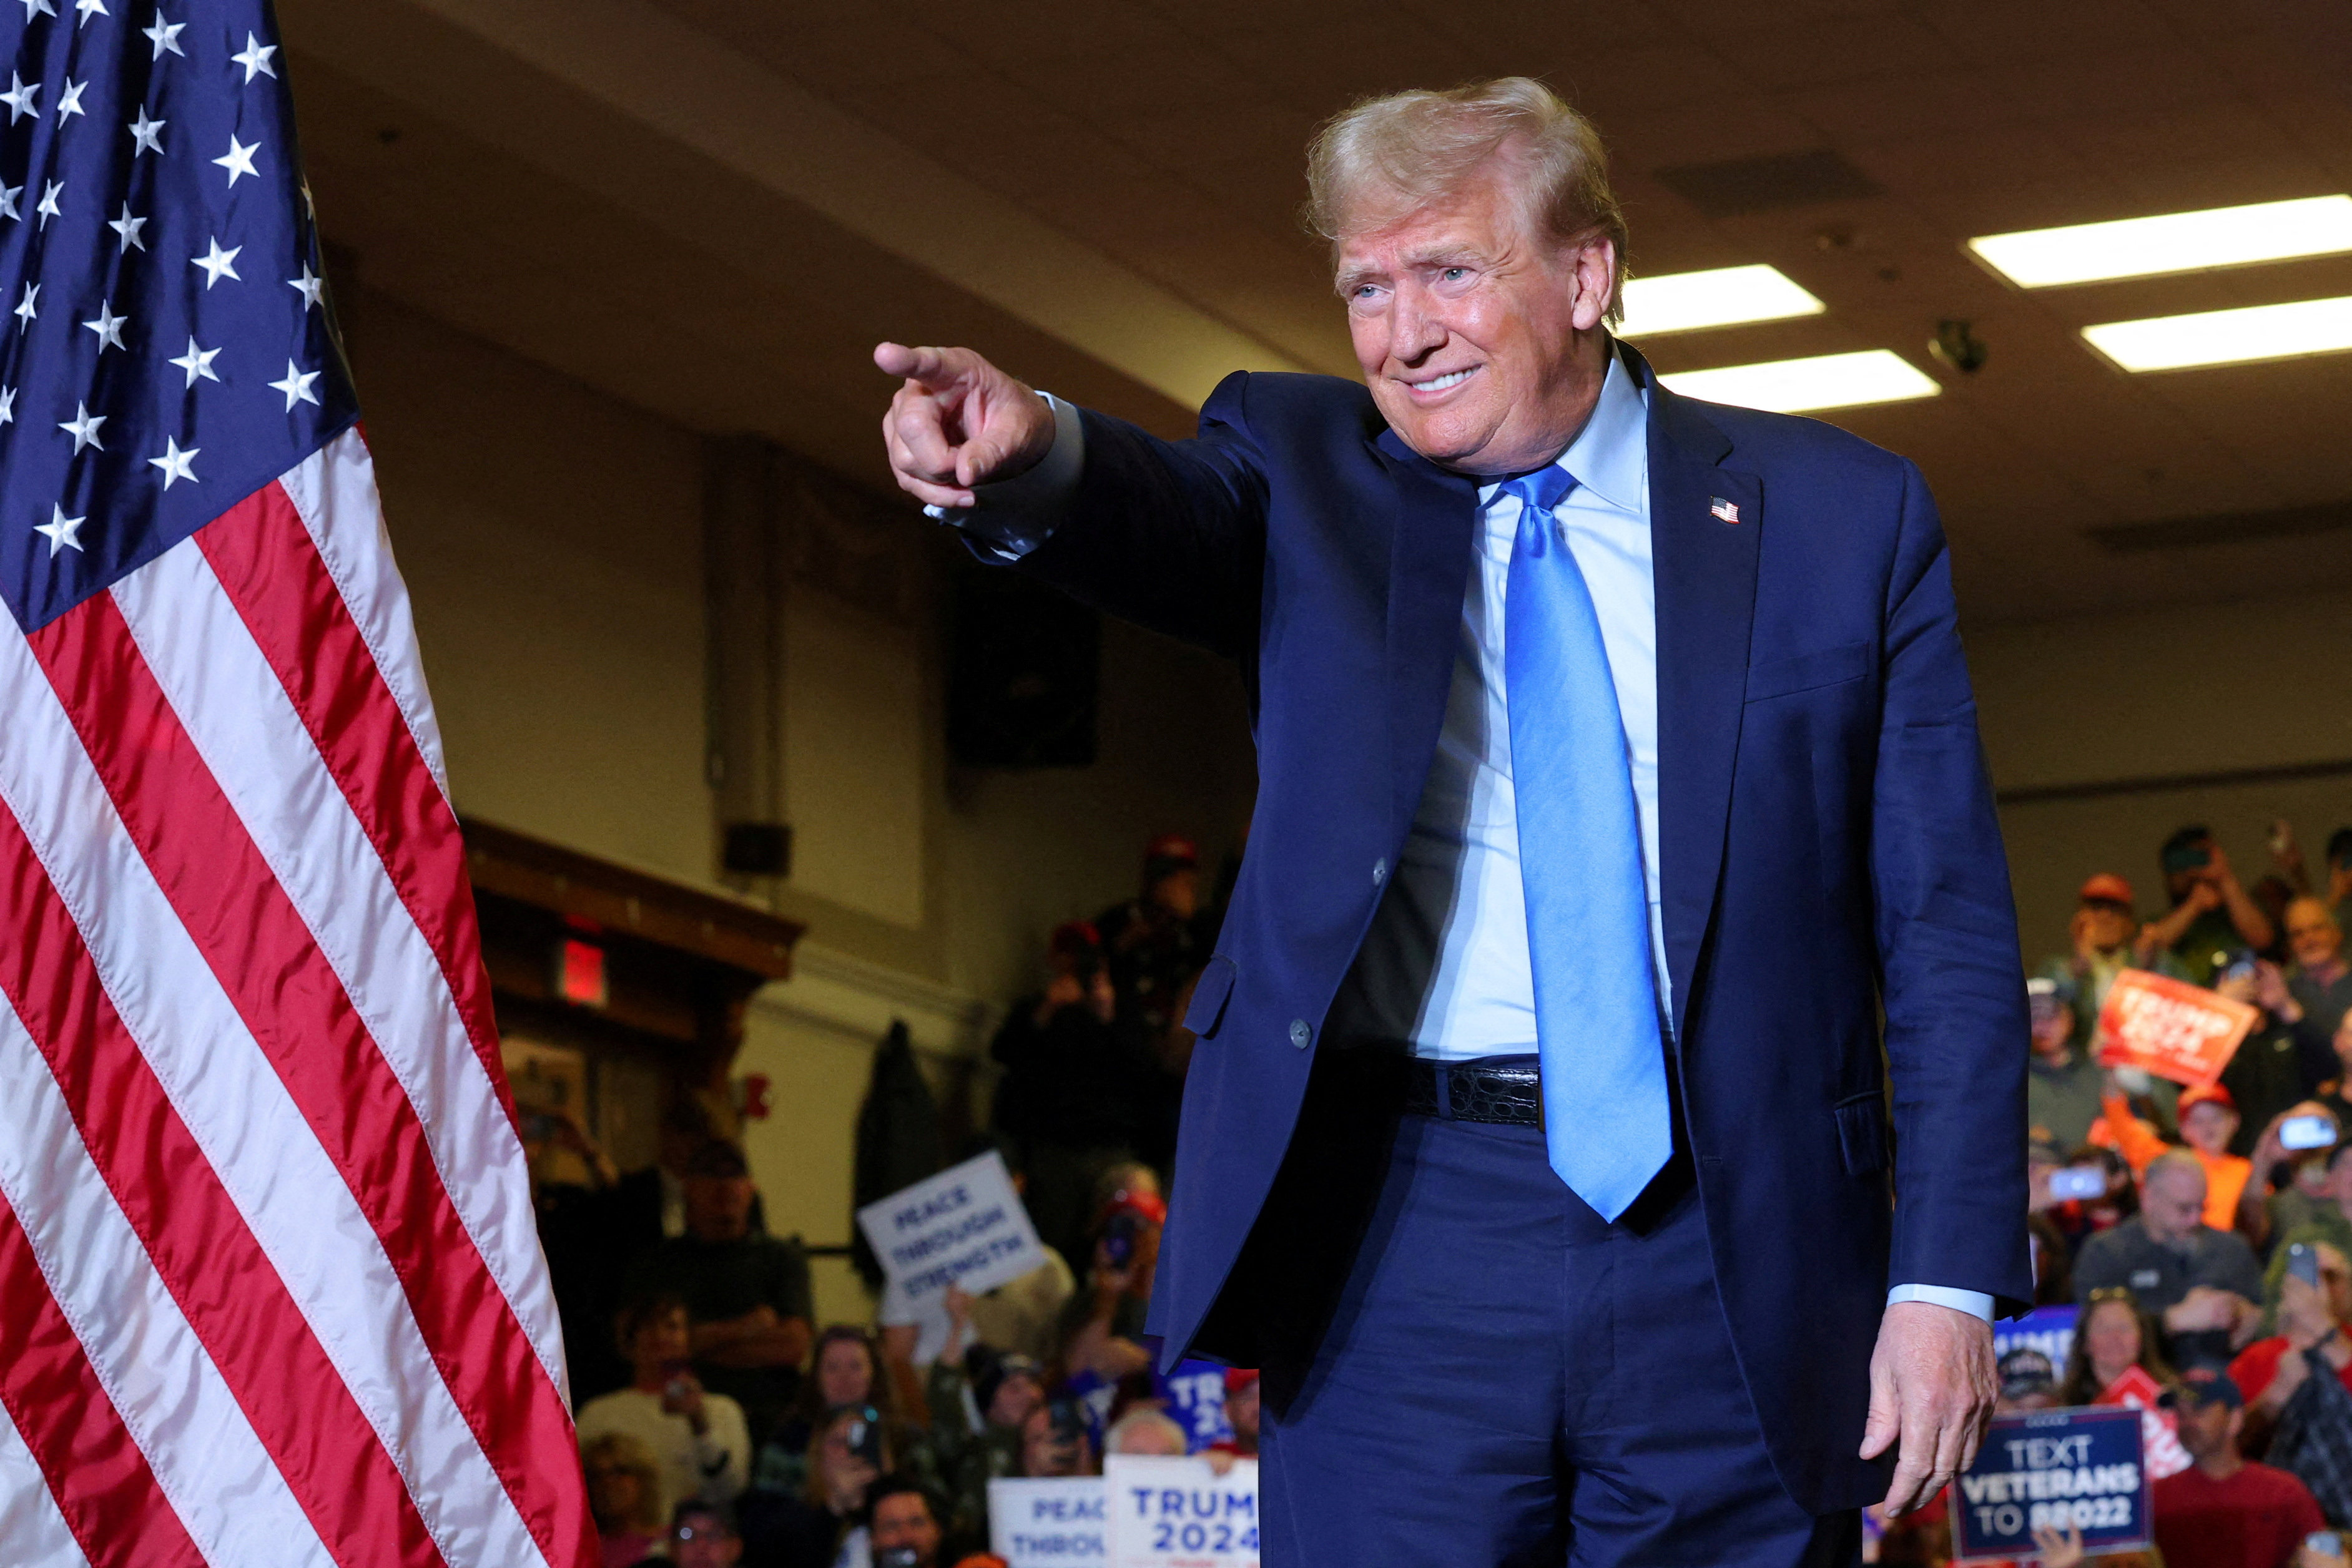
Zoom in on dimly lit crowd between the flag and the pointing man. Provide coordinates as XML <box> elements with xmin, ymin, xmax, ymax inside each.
<box><xmin>541</xmin><ymin>835</ymin><xmax>1258</xmax><ymax>1568</ymax></box>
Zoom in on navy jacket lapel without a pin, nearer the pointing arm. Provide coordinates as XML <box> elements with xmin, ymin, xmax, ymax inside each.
<box><xmin>1374</xmin><ymin>430</ymin><xmax>1477</xmax><ymax>828</ymax></box>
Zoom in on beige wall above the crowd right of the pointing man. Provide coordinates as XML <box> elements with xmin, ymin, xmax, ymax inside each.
<box><xmin>1966</xmin><ymin>592</ymin><xmax>2352</xmax><ymax>964</ymax></box>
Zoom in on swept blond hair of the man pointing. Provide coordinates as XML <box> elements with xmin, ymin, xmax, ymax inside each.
<box><xmin>1306</xmin><ymin>76</ymin><xmax>1628</xmax><ymax>325</ymax></box>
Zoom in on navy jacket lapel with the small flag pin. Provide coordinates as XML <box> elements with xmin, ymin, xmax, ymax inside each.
<box><xmin>1623</xmin><ymin>348</ymin><xmax>1764</xmax><ymax>1041</ymax></box>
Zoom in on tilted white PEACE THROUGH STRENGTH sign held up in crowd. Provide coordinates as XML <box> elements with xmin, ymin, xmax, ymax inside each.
<box><xmin>859</xmin><ymin>1150</ymin><xmax>1045</xmax><ymax>1323</ymax></box>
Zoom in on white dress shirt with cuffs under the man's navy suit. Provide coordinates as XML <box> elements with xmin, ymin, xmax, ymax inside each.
<box><xmin>945</xmin><ymin>364</ymin><xmax>1992</xmax><ymax>1321</ymax></box>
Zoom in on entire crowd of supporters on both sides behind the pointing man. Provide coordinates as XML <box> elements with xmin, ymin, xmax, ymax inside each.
<box><xmin>543</xmin><ymin>823</ymin><xmax>2352</xmax><ymax>1568</ymax></box>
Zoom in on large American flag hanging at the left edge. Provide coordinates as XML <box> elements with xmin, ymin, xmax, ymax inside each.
<box><xmin>0</xmin><ymin>0</ymin><xmax>595</xmax><ymax>1568</ymax></box>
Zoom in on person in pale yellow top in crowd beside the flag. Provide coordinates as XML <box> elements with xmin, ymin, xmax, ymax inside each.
<box><xmin>579</xmin><ymin>1293</ymin><xmax>750</xmax><ymax>1519</ymax></box>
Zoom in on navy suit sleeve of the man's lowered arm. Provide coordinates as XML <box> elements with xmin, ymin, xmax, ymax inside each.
<box><xmin>1870</xmin><ymin>463</ymin><xmax>2032</xmax><ymax>1314</ymax></box>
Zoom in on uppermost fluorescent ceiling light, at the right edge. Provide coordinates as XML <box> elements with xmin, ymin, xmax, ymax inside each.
<box><xmin>1969</xmin><ymin>195</ymin><xmax>2352</xmax><ymax>289</ymax></box>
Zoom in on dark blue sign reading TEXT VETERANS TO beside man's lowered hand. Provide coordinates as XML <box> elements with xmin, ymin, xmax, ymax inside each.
<box><xmin>1952</xmin><ymin>1406</ymin><xmax>2150</xmax><ymax>1559</ymax></box>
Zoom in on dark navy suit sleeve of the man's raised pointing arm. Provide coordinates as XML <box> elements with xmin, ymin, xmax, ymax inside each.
<box><xmin>1018</xmin><ymin>371</ymin><xmax>1266</xmax><ymax>659</ymax></box>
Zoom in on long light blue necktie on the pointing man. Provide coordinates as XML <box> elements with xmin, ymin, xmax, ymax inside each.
<box><xmin>1493</xmin><ymin>463</ymin><xmax>1672</xmax><ymax>1220</ymax></box>
